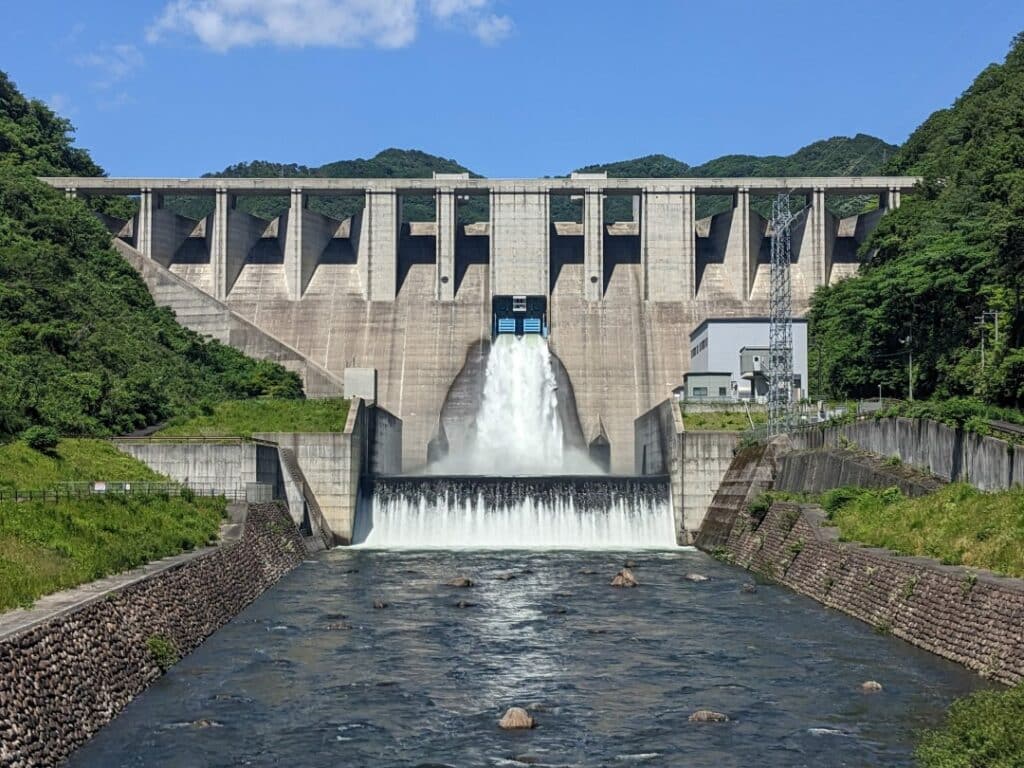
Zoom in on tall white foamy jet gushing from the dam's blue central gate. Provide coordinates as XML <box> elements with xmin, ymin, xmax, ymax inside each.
<box><xmin>427</xmin><ymin>334</ymin><xmax>601</xmax><ymax>476</ymax></box>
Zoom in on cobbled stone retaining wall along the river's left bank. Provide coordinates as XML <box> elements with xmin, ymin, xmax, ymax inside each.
<box><xmin>0</xmin><ymin>505</ymin><xmax>305</xmax><ymax>768</ymax></box>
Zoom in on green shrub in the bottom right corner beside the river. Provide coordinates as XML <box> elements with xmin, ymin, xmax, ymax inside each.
<box><xmin>915</xmin><ymin>685</ymin><xmax>1024</xmax><ymax>768</ymax></box>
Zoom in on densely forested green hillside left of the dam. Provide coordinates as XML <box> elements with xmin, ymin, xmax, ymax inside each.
<box><xmin>0</xmin><ymin>72</ymin><xmax>301</xmax><ymax>440</ymax></box>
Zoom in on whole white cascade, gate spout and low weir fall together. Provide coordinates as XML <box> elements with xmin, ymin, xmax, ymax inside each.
<box><xmin>353</xmin><ymin>335</ymin><xmax>676</xmax><ymax>549</ymax></box>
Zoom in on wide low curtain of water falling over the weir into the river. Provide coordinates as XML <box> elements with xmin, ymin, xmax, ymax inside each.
<box><xmin>354</xmin><ymin>476</ymin><xmax>676</xmax><ymax>549</ymax></box>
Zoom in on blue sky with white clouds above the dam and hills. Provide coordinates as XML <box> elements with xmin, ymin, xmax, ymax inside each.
<box><xmin>0</xmin><ymin>0</ymin><xmax>1024</xmax><ymax>177</ymax></box>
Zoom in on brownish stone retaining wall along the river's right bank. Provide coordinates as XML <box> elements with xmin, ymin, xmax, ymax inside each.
<box><xmin>715</xmin><ymin>504</ymin><xmax>1024</xmax><ymax>684</ymax></box>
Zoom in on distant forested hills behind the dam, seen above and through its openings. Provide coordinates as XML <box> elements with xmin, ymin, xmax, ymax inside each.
<box><xmin>178</xmin><ymin>133</ymin><xmax>897</xmax><ymax>221</ymax></box>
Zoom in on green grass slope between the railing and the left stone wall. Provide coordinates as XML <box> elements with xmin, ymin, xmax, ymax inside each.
<box><xmin>0</xmin><ymin>496</ymin><xmax>226</xmax><ymax>610</ymax></box>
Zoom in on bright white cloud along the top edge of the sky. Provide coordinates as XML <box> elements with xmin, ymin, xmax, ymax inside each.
<box><xmin>146</xmin><ymin>0</ymin><xmax>513</xmax><ymax>52</ymax></box>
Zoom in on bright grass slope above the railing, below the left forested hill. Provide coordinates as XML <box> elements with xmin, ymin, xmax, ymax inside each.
<box><xmin>0</xmin><ymin>438</ymin><xmax>167</xmax><ymax>490</ymax></box>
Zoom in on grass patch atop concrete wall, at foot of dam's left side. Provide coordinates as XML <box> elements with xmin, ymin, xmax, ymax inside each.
<box><xmin>158</xmin><ymin>398</ymin><xmax>349</xmax><ymax>437</ymax></box>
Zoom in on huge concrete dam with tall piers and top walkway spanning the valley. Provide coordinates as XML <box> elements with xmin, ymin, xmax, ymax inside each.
<box><xmin>44</xmin><ymin>174</ymin><xmax>918</xmax><ymax>474</ymax></box>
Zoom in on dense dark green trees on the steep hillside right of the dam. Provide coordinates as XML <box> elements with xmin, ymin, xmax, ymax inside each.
<box><xmin>809</xmin><ymin>37</ymin><xmax>1024</xmax><ymax>408</ymax></box>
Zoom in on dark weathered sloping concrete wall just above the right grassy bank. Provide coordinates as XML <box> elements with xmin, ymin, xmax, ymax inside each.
<box><xmin>772</xmin><ymin>449</ymin><xmax>944</xmax><ymax>497</ymax></box>
